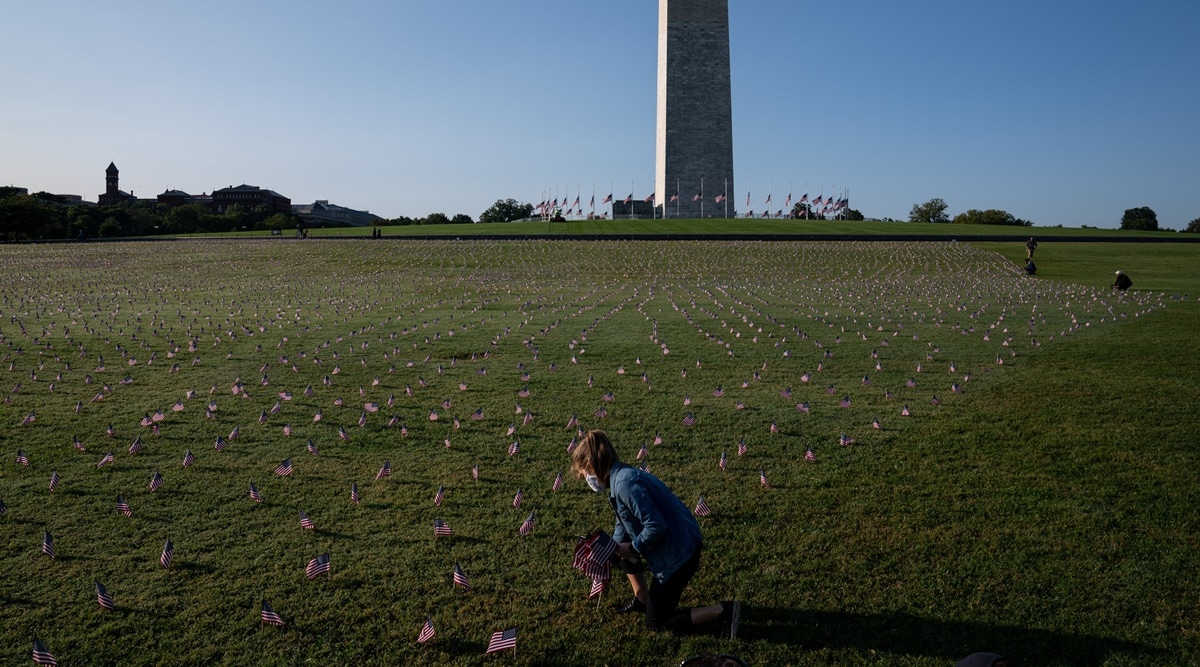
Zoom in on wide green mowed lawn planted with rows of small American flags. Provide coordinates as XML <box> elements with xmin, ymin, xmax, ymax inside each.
<box><xmin>0</xmin><ymin>240</ymin><xmax>1200</xmax><ymax>665</ymax></box>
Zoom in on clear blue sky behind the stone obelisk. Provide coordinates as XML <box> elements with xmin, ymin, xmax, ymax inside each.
<box><xmin>0</xmin><ymin>0</ymin><xmax>1200</xmax><ymax>229</ymax></box>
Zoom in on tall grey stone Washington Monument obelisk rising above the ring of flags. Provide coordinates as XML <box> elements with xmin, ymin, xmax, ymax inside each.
<box><xmin>654</xmin><ymin>0</ymin><xmax>736</xmax><ymax>218</ymax></box>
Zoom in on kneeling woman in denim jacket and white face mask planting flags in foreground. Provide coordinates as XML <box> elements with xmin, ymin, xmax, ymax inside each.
<box><xmin>571</xmin><ymin>431</ymin><xmax>740</xmax><ymax>638</ymax></box>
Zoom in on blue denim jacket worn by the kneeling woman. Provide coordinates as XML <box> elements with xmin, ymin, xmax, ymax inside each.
<box><xmin>608</xmin><ymin>462</ymin><xmax>700</xmax><ymax>583</ymax></box>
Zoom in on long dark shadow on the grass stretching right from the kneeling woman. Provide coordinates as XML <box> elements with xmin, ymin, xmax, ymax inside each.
<box><xmin>740</xmin><ymin>607</ymin><xmax>1163</xmax><ymax>667</ymax></box>
